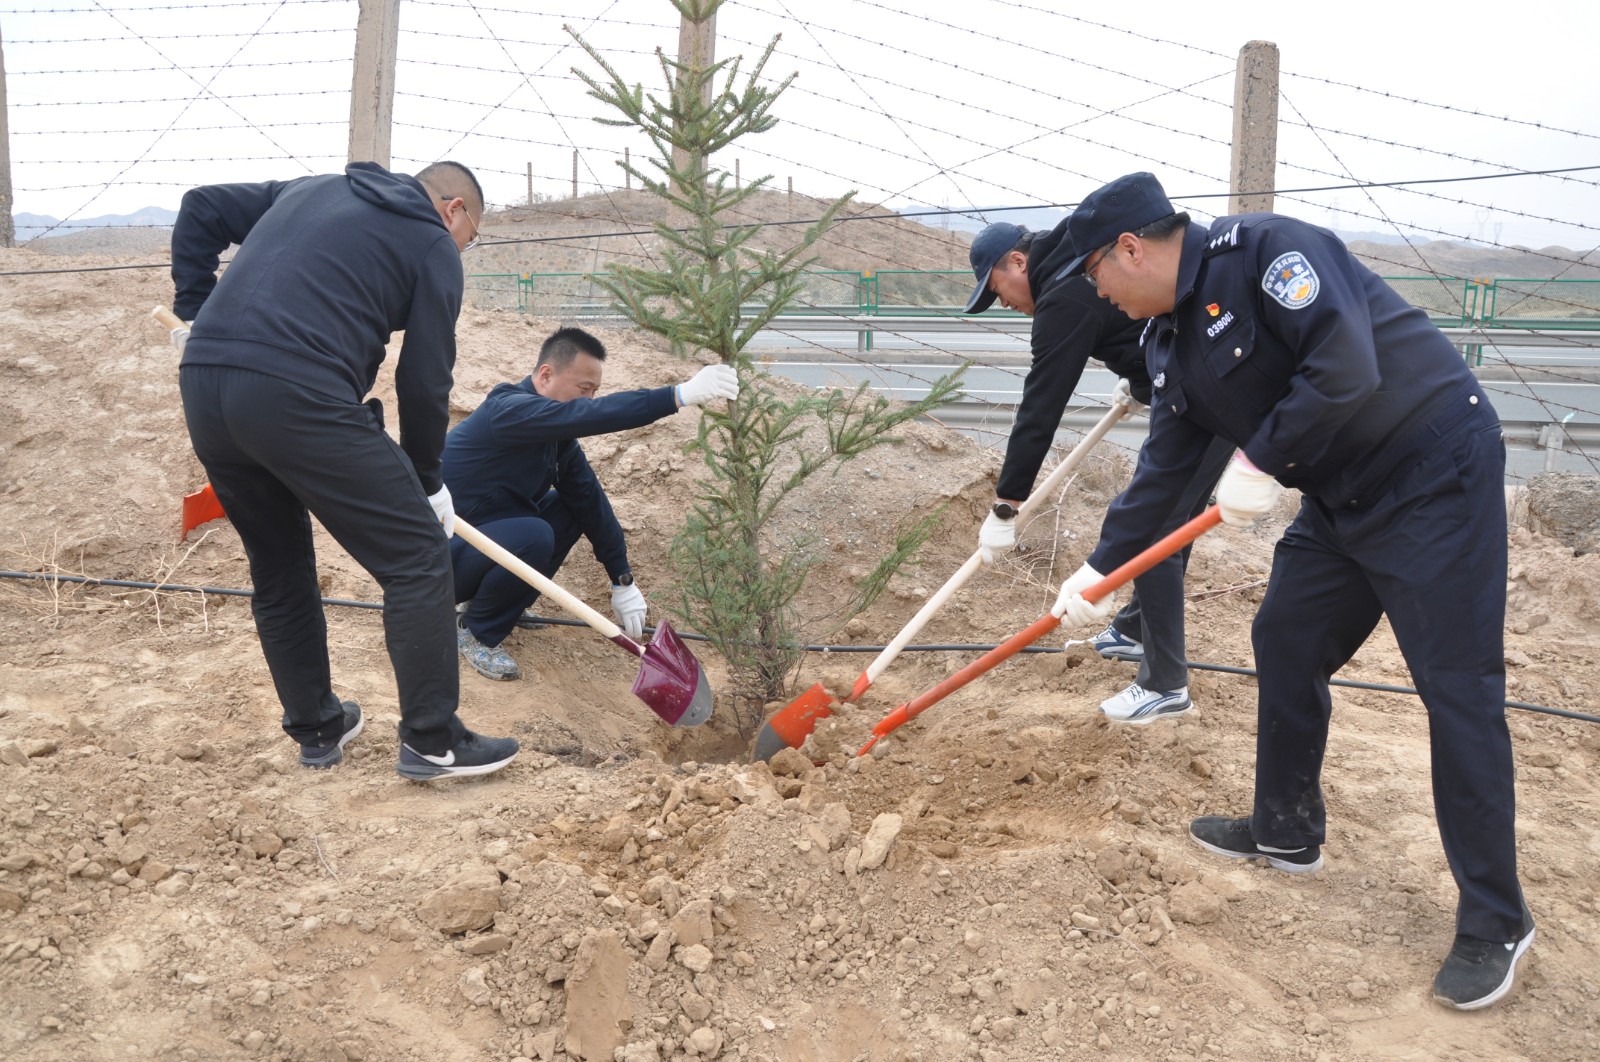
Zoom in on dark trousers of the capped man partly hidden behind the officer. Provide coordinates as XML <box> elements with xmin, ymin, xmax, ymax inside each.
<box><xmin>1110</xmin><ymin>438</ymin><xmax>1234</xmax><ymax>693</ymax></box>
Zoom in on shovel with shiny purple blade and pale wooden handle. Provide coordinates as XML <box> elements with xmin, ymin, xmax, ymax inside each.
<box><xmin>456</xmin><ymin>517</ymin><xmax>712</xmax><ymax>726</ymax></box>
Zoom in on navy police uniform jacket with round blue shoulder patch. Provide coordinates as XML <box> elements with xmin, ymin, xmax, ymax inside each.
<box><xmin>1088</xmin><ymin>214</ymin><xmax>1488</xmax><ymax>571</ymax></box>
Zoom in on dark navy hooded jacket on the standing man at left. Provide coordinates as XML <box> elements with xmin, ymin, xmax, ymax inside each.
<box><xmin>173</xmin><ymin>162</ymin><xmax>462</xmax><ymax>494</ymax></box>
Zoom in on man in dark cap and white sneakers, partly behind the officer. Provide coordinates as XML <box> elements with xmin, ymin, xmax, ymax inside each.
<box><xmin>965</xmin><ymin>221</ymin><xmax>1232</xmax><ymax>723</ymax></box>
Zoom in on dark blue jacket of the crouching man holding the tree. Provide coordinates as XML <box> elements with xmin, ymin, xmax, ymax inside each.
<box><xmin>445</xmin><ymin>376</ymin><xmax>678</xmax><ymax>582</ymax></box>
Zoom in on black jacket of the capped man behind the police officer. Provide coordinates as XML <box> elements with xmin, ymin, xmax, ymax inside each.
<box><xmin>995</xmin><ymin>221</ymin><xmax>1150</xmax><ymax>499</ymax></box>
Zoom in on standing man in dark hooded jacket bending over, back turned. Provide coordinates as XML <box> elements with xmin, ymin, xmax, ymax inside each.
<box><xmin>173</xmin><ymin>162</ymin><xmax>517</xmax><ymax>781</ymax></box>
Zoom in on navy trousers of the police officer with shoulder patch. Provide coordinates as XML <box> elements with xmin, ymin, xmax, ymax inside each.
<box><xmin>1250</xmin><ymin>398</ymin><xmax>1523</xmax><ymax>940</ymax></box>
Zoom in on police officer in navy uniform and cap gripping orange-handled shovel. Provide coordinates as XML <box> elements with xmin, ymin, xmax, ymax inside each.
<box><xmin>1056</xmin><ymin>173</ymin><xmax>1534</xmax><ymax>1009</ymax></box>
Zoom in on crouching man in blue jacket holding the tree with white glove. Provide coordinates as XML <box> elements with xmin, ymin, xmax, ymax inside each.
<box><xmin>445</xmin><ymin>328</ymin><xmax>739</xmax><ymax>680</ymax></box>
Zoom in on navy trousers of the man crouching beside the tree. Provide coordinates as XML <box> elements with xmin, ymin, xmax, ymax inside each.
<box><xmin>450</xmin><ymin>491</ymin><xmax>582</xmax><ymax>648</ymax></box>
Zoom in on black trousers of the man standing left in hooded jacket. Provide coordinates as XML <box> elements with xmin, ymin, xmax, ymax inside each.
<box><xmin>178</xmin><ymin>365</ymin><xmax>466</xmax><ymax>755</ymax></box>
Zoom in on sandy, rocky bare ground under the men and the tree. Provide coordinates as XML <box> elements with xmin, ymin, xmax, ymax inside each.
<box><xmin>0</xmin><ymin>251</ymin><xmax>1600</xmax><ymax>1062</ymax></box>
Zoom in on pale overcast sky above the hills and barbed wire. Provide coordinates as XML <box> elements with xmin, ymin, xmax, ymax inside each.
<box><xmin>0</xmin><ymin>0</ymin><xmax>1600</xmax><ymax>248</ymax></box>
